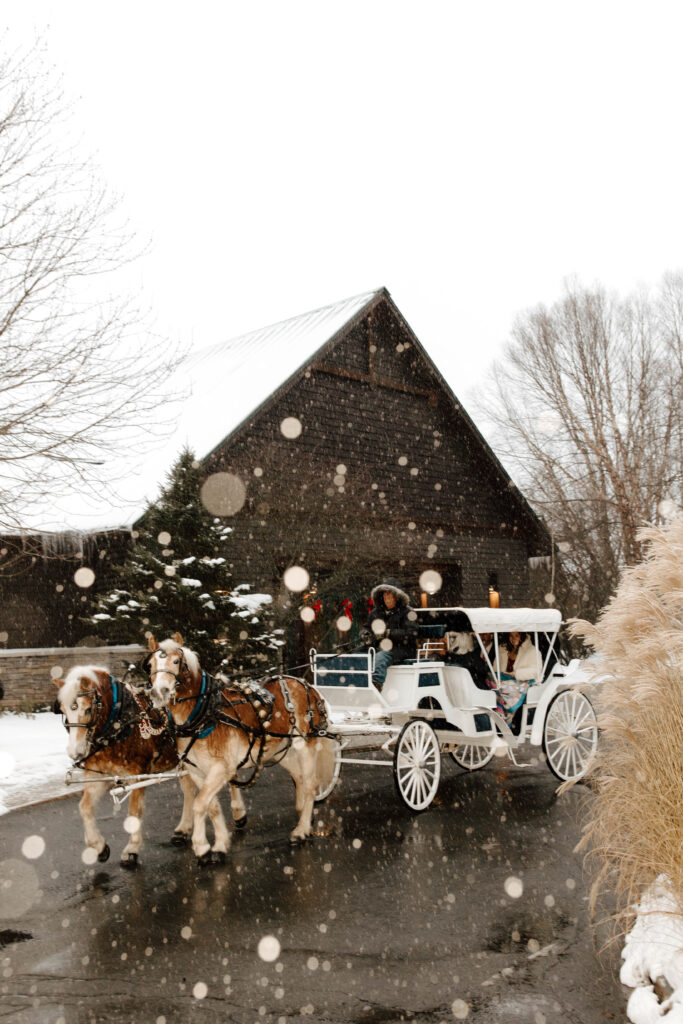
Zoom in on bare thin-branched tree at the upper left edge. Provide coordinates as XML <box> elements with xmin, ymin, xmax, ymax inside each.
<box><xmin>0</xmin><ymin>40</ymin><xmax>185</xmax><ymax>532</ymax></box>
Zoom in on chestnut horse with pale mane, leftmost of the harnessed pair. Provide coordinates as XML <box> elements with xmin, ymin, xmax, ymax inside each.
<box><xmin>54</xmin><ymin>666</ymin><xmax>201</xmax><ymax>867</ymax></box>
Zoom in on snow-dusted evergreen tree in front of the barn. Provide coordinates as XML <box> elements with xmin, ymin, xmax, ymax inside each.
<box><xmin>87</xmin><ymin>449</ymin><xmax>282</xmax><ymax>675</ymax></box>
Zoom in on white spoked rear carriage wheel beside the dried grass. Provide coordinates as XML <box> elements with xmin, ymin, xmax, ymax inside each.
<box><xmin>543</xmin><ymin>690</ymin><xmax>598</xmax><ymax>782</ymax></box>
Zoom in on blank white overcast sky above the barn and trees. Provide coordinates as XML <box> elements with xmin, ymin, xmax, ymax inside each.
<box><xmin>0</xmin><ymin>0</ymin><xmax>683</xmax><ymax>528</ymax></box>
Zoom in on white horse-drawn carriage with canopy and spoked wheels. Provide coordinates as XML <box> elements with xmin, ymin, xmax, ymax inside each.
<box><xmin>310</xmin><ymin>608</ymin><xmax>598</xmax><ymax>811</ymax></box>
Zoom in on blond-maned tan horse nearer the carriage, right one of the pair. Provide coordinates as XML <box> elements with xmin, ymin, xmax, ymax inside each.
<box><xmin>146</xmin><ymin>633</ymin><xmax>335</xmax><ymax>863</ymax></box>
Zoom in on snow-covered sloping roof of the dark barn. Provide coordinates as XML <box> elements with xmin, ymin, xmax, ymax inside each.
<box><xmin>15</xmin><ymin>289</ymin><xmax>384</xmax><ymax>536</ymax></box>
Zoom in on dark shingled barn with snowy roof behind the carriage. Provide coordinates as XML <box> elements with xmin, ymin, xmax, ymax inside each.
<box><xmin>3</xmin><ymin>289</ymin><xmax>551</xmax><ymax>660</ymax></box>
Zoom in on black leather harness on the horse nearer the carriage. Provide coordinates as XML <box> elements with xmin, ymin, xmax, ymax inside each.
<box><xmin>167</xmin><ymin>671</ymin><xmax>328</xmax><ymax>788</ymax></box>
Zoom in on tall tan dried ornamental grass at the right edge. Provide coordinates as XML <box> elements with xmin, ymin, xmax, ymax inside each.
<box><xmin>571</xmin><ymin>518</ymin><xmax>683</xmax><ymax>937</ymax></box>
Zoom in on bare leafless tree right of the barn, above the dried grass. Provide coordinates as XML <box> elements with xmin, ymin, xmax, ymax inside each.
<box><xmin>479</xmin><ymin>273</ymin><xmax>683</xmax><ymax>617</ymax></box>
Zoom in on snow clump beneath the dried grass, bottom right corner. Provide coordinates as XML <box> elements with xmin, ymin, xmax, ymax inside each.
<box><xmin>620</xmin><ymin>874</ymin><xmax>683</xmax><ymax>1024</ymax></box>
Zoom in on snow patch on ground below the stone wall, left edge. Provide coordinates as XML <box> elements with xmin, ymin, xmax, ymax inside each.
<box><xmin>0</xmin><ymin>711</ymin><xmax>76</xmax><ymax>814</ymax></box>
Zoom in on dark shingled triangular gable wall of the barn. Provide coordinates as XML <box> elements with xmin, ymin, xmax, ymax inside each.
<box><xmin>196</xmin><ymin>290</ymin><xmax>550</xmax><ymax>647</ymax></box>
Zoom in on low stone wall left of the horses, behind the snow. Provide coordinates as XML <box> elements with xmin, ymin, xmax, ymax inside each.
<box><xmin>0</xmin><ymin>644</ymin><xmax>146</xmax><ymax>711</ymax></box>
